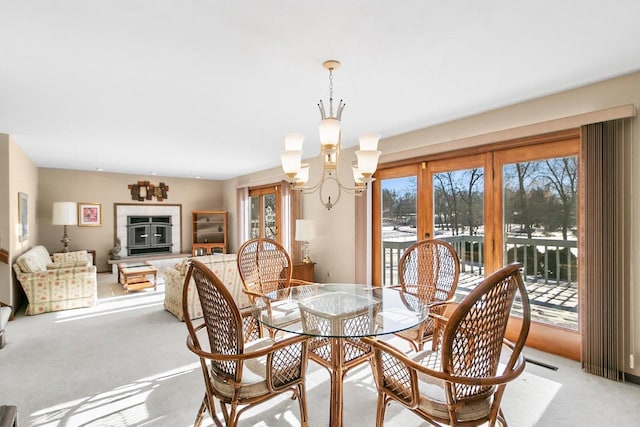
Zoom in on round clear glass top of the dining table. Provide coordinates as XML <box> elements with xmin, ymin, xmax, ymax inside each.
<box><xmin>253</xmin><ymin>283</ymin><xmax>429</xmax><ymax>338</ymax></box>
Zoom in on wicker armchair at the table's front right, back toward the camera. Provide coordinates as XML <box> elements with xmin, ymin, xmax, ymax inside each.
<box><xmin>363</xmin><ymin>263</ymin><xmax>531</xmax><ymax>427</ymax></box>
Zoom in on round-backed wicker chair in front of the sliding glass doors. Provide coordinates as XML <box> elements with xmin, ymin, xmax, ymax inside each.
<box><xmin>396</xmin><ymin>239</ymin><xmax>460</xmax><ymax>351</ymax></box>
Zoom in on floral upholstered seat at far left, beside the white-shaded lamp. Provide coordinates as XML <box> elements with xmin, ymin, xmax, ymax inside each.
<box><xmin>13</xmin><ymin>246</ymin><xmax>98</xmax><ymax>315</ymax></box>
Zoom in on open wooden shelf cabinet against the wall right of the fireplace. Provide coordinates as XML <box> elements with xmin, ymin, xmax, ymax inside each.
<box><xmin>191</xmin><ymin>211</ymin><xmax>227</xmax><ymax>256</ymax></box>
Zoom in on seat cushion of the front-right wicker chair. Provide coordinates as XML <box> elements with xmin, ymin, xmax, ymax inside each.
<box><xmin>411</xmin><ymin>350</ymin><xmax>493</xmax><ymax>422</ymax></box>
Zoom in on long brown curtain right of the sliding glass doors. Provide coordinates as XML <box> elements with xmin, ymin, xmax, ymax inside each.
<box><xmin>579</xmin><ymin>119</ymin><xmax>631</xmax><ymax>380</ymax></box>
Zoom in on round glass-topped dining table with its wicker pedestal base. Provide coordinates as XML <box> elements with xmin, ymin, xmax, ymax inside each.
<box><xmin>253</xmin><ymin>283</ymin><xmax>429</xmax><ymax>427</ymax></box>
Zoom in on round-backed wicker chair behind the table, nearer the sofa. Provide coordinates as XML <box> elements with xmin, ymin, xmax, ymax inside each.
<box><xmin>237</xmin><ymin>238</ymin><xmax>309</xmax><ymax>338</ymax></box>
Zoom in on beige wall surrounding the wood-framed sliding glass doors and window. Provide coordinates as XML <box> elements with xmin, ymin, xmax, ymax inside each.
<box><xmin>225</xmin><ymin>73</ymin><xmax>640</xmax><ymax>375</ymax></box>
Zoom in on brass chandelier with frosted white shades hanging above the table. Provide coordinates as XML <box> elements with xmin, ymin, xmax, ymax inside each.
<box><xmin>280</xmin><ymin>60</ymin><xmax>381</xmax><ymax>210</ymax></box>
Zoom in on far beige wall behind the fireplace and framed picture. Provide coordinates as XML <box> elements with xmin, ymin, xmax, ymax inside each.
<box><xmin>38</xmin><ymin>168</ymin><xmax>222</xmax><ymax>271</ymax></box>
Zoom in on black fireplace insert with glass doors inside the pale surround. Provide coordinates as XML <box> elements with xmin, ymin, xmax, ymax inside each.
<box><xmin>127</xmin><ymin>215</ymin><xmax>173</xmax><ymax>256</ymax></box>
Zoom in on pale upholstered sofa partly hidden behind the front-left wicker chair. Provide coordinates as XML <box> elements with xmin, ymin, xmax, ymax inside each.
<box><xmin>162</xmin><ymin>254</ymin><xmax>251</xmax><ymax>321</ymax></box>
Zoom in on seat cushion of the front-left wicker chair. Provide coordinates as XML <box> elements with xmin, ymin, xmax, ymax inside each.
<box><xmin>211</xmin><ymin>338</ymin><xmax>275</xmax><ymax>399</ymax></box>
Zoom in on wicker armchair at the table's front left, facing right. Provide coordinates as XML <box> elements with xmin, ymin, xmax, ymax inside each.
<box><xmin>182</xmin><ymin>260</ymin><xmax>308</xmax><ymax>427</ymax></box>
